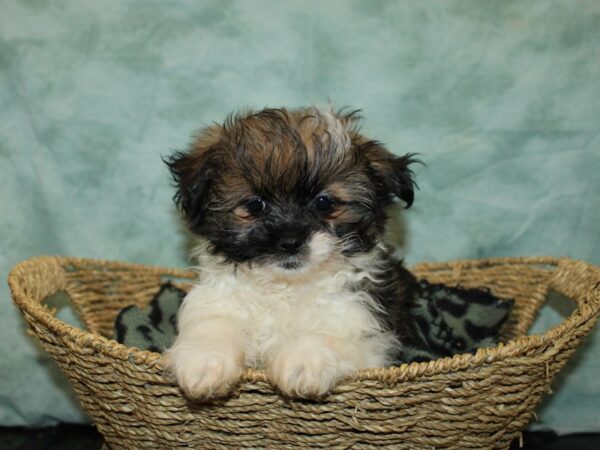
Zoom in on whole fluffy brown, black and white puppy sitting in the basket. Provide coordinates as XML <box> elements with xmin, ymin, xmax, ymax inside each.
<box><xmin>166</xmin><ymin>107</ymin><xmax>414</xmax><ymax>399</ymax></box>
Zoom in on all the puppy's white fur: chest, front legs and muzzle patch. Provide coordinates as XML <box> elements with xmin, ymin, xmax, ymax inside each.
<box><xmin>166</xmin><ymin>232</ymin><xmax>398</xmax><ymax>398</ymax></box>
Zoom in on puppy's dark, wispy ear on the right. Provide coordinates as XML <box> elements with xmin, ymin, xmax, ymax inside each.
<box><xmin>360</xmin><ymin>141</ymin><xmax>421</xmax><ymax>208</ymax></box>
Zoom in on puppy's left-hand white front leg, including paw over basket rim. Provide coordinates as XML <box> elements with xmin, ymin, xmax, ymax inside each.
<box><xmin>165</xmin><ymin>315</ymin><xmax>244</xmax><ymax>399</ymax></box>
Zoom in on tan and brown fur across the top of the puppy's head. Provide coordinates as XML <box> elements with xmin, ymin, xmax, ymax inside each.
<box><xmin>180</xmin><ymin>107</ymin><xmax>387</xmax><ymax>215</ymax></box>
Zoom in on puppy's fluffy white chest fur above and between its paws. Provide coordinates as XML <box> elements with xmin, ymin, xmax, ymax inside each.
<box><xmin>179</xmin><ymin>260</ymin><xmax>387</xmax><ymax>367</ymax></box>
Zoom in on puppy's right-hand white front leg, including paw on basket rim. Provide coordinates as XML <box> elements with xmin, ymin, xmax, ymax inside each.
<box><xmin>266</xmin><ymin>335</ymin><xmax>360</xmax><ymax>398</ymax></box>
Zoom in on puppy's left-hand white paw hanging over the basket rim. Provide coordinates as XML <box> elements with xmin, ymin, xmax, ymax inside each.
<box><xmin>165</xmin><ymin>351</ymin><xmax>243</xmax><ymax>400</ymax></box>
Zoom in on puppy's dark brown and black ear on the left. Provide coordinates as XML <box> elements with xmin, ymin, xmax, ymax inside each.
<box><xmin>163</xmin><ymin>130</ymin><xmax>221</xmax><ymax>231</ymax></box>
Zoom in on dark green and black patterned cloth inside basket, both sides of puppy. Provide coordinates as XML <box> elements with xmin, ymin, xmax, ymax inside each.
<box><xmin>115</xmin><ymin>280</ymin><xmax>513</xmax><ymax>363</ymax></box>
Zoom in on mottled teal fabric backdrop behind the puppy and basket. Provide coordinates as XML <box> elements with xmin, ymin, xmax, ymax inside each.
<box><xmin>0</xmin><ymin>0</ymin><xmax>600</xmax><ymax>432</ymax></box>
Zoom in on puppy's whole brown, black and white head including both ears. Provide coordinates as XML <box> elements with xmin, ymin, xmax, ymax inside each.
<box><xmin>166</xmin><ymin>108</ymin><xmax>414</xmax><ymax>273</ymax></box>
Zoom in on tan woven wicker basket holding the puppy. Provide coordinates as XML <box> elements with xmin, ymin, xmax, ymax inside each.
<box><xmin>9</xmin><ymin>257</ymin><xmax>600</xmax><ymax>449</ymax></box>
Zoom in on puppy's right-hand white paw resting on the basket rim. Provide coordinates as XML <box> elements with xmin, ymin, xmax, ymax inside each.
<box><xmin>267</xmin><ymin>341</ymin><xmax>352</xmax><ymax>398</ymax></box>
